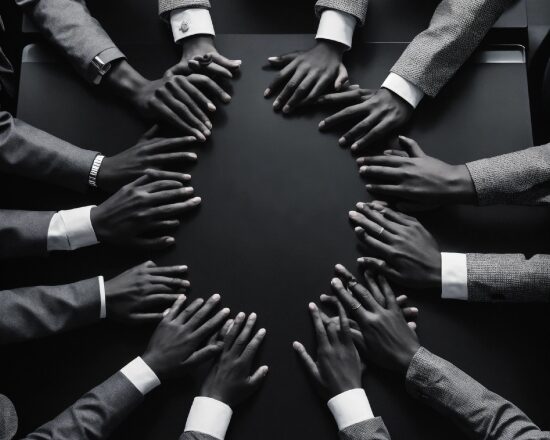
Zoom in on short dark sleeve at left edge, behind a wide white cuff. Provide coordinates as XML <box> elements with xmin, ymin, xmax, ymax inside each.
<box><xmin>0</xmin><ymin>209</ymin><xmax>55</xmax><ymax>259</ymax></box>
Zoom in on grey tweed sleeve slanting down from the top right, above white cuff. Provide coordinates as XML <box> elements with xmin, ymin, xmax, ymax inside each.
<box><xmin>391</xmin><ymin>0</ymin><xmax>516</xmax><ymax>97</ymax></box>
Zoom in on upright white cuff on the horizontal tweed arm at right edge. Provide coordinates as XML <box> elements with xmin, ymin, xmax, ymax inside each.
<box><xmin>441</xmin><ymin>252</ymin><xmax>468</xmax><ymax>301</ymax></box>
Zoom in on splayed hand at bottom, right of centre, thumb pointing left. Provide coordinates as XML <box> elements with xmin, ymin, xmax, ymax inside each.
<box><xmin>293</xmin><ymin>303</ymin><xmax>363</xmax><ymax>399</ymax></box>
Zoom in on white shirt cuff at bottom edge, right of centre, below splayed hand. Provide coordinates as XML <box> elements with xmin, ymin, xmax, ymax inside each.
<box><xmin>327</xmin><ymin>388</ymin><xmax>374</xmax><ymax>431</ymax></box>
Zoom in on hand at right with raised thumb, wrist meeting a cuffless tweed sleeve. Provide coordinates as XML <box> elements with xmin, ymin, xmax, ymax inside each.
<box><xmin>357</xmin><ymin>136</ymin><xmax>476</xmax><ymax>205</ymax></box>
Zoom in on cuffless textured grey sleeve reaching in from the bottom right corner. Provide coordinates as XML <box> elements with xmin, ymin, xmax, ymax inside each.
<box><xmin>406</xmin><ymin>348</ymin><xmax>550</xmax><ymax>440</ymax></box>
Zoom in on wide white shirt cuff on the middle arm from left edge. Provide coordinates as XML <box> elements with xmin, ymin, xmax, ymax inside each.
<box><xmin>47</xmin><ymin>206</ymin><xmax>98</xmax><ymax>251</ymax></box>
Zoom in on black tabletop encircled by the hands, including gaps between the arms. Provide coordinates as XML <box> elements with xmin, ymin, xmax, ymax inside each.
<box><xmin>6</xmin><ymin>35</ymin><xmax>550</xmax><ymax>440</ymax></box>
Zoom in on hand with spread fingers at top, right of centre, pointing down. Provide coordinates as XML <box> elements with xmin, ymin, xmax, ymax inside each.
<box><xmin>264</xmin><ymin>40</ymin><xmax>348</xmax><ymax>113</ymax></box>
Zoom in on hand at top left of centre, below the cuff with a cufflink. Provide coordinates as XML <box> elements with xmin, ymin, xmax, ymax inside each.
<box><xmin>168</xmin><ymin>35</ymin><xmax>241</xmax><ymax>78</ymax></box>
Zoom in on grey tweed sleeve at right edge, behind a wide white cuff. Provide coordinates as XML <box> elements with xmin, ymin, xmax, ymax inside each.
<box><xmin>466</xmin><ymin>254</ymin><xmax>550</xmax><ymax>302</ymax></box>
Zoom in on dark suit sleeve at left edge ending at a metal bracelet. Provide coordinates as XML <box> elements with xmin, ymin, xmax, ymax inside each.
<box><xmin>0</xmin><ymin>112</ymin><xmax>98</xmax><ymax>191</ymax></box>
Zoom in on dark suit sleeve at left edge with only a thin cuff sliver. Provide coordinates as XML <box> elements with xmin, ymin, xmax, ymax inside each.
<box><xmin>0</xmin><ymin>278</ymin><xmax>101</xmax><ymax>344</ymax></box>
